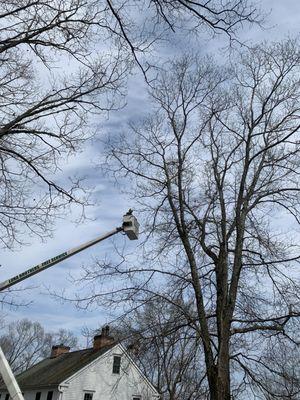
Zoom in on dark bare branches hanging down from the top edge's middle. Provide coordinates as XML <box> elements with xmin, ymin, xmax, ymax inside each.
<box><xmin>107</xmin><ymin>0</ymin><xmax>264</xmax><ymax>72</ymax></box>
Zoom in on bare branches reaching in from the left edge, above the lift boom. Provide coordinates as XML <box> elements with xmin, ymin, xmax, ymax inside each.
<box><xmin>0</xmin><ymin>0</ymin><xmax>128</xmax><ymax>247</ymax></box>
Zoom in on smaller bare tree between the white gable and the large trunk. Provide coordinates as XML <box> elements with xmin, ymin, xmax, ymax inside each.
<box><xmin>118</xmin><ymin>298</ymin><xmax>207</xmax><ymax>400</ymax></box>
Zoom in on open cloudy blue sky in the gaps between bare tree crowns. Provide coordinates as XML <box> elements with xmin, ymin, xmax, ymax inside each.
<box><xmin>0</xmin><ymin>0</ymin><xmax>300</xmax><ymax>344</ymax></box>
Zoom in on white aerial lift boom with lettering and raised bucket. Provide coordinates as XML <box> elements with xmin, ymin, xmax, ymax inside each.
<box><xmin>0</xmin><ymin>210</ymin><xmax>139</xmax><ymax>400</ymax></box>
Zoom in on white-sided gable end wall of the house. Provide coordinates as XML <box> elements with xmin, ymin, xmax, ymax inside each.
<box><xmin>61</xmin><ymin>345</ymin><xmax>157</xmax><ymax>400</ymax></box>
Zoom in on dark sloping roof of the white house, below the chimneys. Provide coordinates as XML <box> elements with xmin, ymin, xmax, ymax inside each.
<box><xmin>0</xmin><ymin>344</ymin><xmax>116</xmax><ymax>390</ymax></box>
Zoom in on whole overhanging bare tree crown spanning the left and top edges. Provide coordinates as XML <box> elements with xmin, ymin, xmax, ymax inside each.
<box><xmin>0</xmin><ymin>0</ymin><xmax>259</xmax><ymax>247</ymax></box>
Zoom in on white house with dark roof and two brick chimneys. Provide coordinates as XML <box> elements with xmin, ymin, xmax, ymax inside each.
<box><xmin>0</xmin><ymin>327</ymin><xmax>160</xmax><ymax>400</ymax></box>
